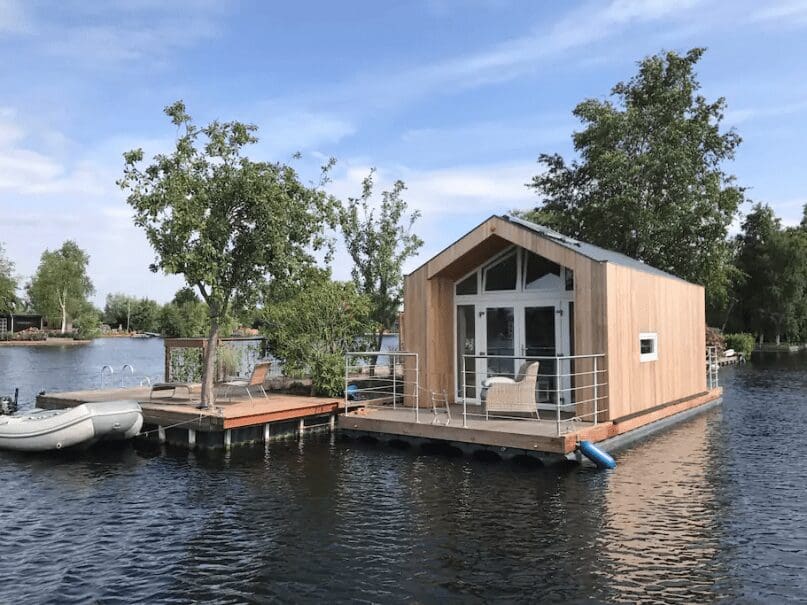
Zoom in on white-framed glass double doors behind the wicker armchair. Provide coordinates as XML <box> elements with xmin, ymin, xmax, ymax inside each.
<box><xmin>456</xmin><ymin>302</ymin><xmax>569</xmax><ymax>407</ymax></box>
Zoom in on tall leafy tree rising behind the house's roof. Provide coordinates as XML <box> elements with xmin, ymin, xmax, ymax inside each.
<box><xmin>525</xmin><ymin>48</ymin><xmax>744</xmax><ymax>304</ymax></box>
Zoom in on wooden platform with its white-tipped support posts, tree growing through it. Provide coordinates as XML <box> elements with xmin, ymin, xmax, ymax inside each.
<box><xmin>36</xmin><ymin>384</ymin><xmax>344</xmax><ymax>449</ymax></box>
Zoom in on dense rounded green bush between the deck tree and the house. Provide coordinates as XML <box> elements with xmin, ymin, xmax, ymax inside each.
<box><xmin>263</xmin><ymin>277</ymin><xmax>373</xmax><ymax>396</ymax></box>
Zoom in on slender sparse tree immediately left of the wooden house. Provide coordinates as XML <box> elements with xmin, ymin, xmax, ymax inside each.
<box><xmin>339</xmin><ymin>172</ymin><xmax>423</xmax><ymax>365</ymax></box>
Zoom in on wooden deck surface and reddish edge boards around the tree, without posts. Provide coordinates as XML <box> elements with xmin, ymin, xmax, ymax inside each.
<box><xmin>37</xmin><ymin>384</ymin><xmax>343</xmax><ymax>432</ymax></box>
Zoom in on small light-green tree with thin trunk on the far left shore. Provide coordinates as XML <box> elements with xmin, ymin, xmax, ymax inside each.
<box><xmin>28</xmin><ymin>240</ymin><xmax>95</xmax><ymax>334</ymax></box>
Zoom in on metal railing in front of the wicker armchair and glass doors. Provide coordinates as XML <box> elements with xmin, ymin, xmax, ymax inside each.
<box><xmin>457</xmin><ymin>353</ymin><xmax>608</xmax><ymax>435</ymax></box>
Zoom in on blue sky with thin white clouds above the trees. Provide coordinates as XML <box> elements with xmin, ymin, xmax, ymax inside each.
<box><xmin>0</xmin><ymin>0</ymin><xmax>807</xmax><ymax>303</ymax></box>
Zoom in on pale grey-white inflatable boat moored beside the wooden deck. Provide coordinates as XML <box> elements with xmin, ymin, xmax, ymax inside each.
<box><xmin>0</xmin><ymin>400</ymin><xmax>143</xmax><ymax>452</ymax></box>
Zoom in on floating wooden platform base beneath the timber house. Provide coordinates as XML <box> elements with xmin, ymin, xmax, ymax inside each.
<box><xmin>338</xmin><ymin>388</ymin><xmax>723</xmax><ymax>464</ymax></box>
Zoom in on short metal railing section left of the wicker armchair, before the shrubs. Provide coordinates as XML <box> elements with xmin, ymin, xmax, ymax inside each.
<box><xmin>345</xmin><ymin>351</ymin><xmax>420</xmax><ymax>422</ymax></box>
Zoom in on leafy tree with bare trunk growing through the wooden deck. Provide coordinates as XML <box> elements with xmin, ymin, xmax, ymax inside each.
<box><xmin>118</xmin><ymin>101</ymin><xmax>332</xmax><ymax>406</ymax></box>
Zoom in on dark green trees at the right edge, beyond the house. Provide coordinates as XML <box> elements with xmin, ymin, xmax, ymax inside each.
<box><xmin>730</xmin><ymin>204</ymin><xmax>807</xmax><ymax>342</ymax></box>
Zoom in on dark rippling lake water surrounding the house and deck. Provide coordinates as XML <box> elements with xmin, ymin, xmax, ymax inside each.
<box><xmin>0</xmin><ymin>340</ymin><xmax>807</xmax><ymax>603</ymax></box>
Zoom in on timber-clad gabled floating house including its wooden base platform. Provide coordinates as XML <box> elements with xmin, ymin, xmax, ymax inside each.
<box><xmin>344</xmin><ymin>216</ymin><xmax>720</xmax><ymax>453</ymax></box>
